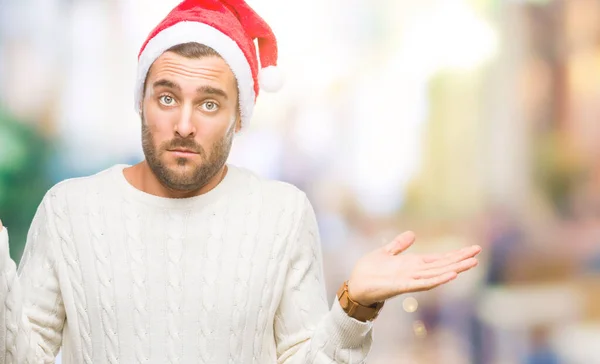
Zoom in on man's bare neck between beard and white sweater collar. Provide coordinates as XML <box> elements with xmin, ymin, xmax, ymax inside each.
<box><xmin>123</xmin><ymin>161</ymin><xmax>227</xmax><ymax>199</ymax></box>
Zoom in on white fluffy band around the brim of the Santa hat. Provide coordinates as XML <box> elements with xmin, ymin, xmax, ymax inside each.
<box><xmin>134</xmin><ymin>21</ymin><xmax>255</xmax><ymax>127</ymax></box>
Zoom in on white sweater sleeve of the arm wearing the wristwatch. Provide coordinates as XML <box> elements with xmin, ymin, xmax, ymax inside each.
<box><xmin>274</xmin><ymin>196</ymin><xmax>372</xmax><ymax>364</ymax></box>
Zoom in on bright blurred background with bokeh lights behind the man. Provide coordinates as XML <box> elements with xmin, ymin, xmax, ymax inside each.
<box><xmin>0</xmin><ymin>0</ymin><xmax>600</xmax><ymax>364</ymax></box>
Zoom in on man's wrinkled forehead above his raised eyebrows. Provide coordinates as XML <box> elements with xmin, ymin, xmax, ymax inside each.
<box><xmin>147</xmin><ymin>52</ymin><xmax>237</xmax><ymax>93</ymax></box>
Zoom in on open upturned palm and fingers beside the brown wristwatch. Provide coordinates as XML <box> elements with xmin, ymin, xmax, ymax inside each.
<box><xmin>348</xmin><ymin>231</ymin><xmax>481</xmax><ymax>306</ymax></box>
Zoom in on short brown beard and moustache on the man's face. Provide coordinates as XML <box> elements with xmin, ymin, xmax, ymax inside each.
<box><xmin>142</xmin><ymin>119</ymin><xmax>234</xmax><ymax>192</ymax></box>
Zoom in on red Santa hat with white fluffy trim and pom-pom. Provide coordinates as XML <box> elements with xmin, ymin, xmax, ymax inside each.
<box><xmin>134</xmin><ymin>0</ymin><xmax>282</xmax><ymax>126</ymax></box>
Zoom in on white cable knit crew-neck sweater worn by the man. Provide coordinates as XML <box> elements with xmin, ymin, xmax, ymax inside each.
<box><xmin>0</xmin><ymin>165</ymin><xmax>372</xmax><ymax>364</ymax></box>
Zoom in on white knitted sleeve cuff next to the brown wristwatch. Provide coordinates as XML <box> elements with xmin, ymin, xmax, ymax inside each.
<box><xmin>331</xmin><ymin>298</ymin><xmax>373</xmax><ymax>348</ymax></box>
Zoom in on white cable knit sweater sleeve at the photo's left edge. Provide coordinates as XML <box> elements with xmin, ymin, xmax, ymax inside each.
<box><xmin>0</xmin><ymin>196</ymin><xmax>65</xmax><ymax>364</ymax></box>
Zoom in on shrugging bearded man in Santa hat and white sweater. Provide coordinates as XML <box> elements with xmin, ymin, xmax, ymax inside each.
<box><xmin>0</xmin><ymin>0</ymin><xmax>480</xmax><ymax>364</ymax></box>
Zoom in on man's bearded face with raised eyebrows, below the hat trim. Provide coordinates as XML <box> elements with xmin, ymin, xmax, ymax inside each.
<box><xmin>142</xmin><ymin>52</ymin><xmax>240</xmax><ymax>191</ymax></box>
